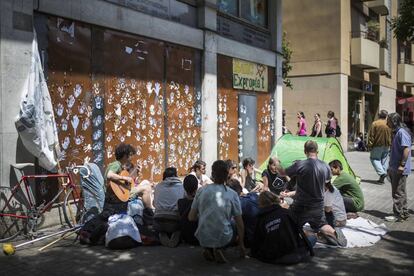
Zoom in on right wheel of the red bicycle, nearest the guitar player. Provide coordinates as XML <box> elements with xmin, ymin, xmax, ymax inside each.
<box><xmin>63</xmin><ymin>188</ymin><xmax>102</xmax><ymax>227</ymax></box>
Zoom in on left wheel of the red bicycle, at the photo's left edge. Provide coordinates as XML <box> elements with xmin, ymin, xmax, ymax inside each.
<box><xmin>0</xmin><ymin>201</ymin><xmax>27</xmax><ymax>242</ymax></box>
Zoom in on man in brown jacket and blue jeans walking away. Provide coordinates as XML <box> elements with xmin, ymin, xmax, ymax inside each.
<box><xmin>368</xmin><ymin>110</ymin><xmax>391</xmax><ymax>184</ymax></box>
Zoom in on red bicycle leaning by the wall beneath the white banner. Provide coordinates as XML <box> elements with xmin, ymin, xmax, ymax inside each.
<box><xmin>0</xmin><ymin>163</ymin><xmax>102</xmax><ymax>242</ymax></box>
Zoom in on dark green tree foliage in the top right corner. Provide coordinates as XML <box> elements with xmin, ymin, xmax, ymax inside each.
<box><xmin>392</xmin><ymin>0</ymin><xmax>414</xmax><ymax>43</ymax></box>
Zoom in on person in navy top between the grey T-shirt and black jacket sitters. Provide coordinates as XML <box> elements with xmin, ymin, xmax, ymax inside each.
<box><xmin>227</xmin><ymin>178</ymin><xmax>259</xmax><ymax>248</ymax></box>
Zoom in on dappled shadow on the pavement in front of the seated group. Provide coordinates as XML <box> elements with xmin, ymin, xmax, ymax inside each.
<box><xmin>0</xmin><ymin>242</ymin><xmax>414</xmax><ymax>275</ymax></box>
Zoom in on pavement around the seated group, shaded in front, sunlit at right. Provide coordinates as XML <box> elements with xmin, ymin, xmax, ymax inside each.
<box><xmin>0</xmin><ymin>152</ymin><xmax>414</xmax><ymax>276</ymax></box>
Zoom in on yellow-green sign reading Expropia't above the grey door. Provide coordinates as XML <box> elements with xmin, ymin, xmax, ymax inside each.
<box><xmin>233</xmin><ymin>58</ymin><xmax>268</xmax><ymax>92</ymax></box>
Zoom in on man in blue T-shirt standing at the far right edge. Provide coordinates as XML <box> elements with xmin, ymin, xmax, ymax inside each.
<box><xmin>385</xmin><ymin>113</ymin><xmax>412</xmax><ymax>221</ymax></box>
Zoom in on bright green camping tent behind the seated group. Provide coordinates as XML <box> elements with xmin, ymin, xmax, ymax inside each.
<box><xmin>257</xmin><ymin>134</ymin><xmax>359</xmax><ymax>182</ymax></box>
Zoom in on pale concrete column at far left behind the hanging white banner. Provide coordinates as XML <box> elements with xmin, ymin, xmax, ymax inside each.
<box><xmin>0</xmin><ymin>0</ymin><xmax>34</xmax><ymax>186</ymax></box>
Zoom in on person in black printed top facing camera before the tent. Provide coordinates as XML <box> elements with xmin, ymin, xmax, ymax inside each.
<box><xmin>262</xmin><ymin>157</ymin><xmax>289</xmax><ymax>195</ymax></box>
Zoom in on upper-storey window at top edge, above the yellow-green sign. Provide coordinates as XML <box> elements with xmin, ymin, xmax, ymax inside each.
<box><xmin>217</xmin><ymin>0</ymin><xmax>267</xmax><ymax>27</ymax></box>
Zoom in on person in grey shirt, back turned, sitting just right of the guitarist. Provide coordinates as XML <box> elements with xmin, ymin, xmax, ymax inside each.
<box><xmin>154</xmin><ymin>167</ymin><xmax>185</xmax><ymax>247</ymax></box>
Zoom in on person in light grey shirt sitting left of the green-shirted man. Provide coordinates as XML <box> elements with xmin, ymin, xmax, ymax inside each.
<box><xmin>324</xmin><ymin>182</ymin><xmax>346</xmax><ymax>227</ymax></box>
